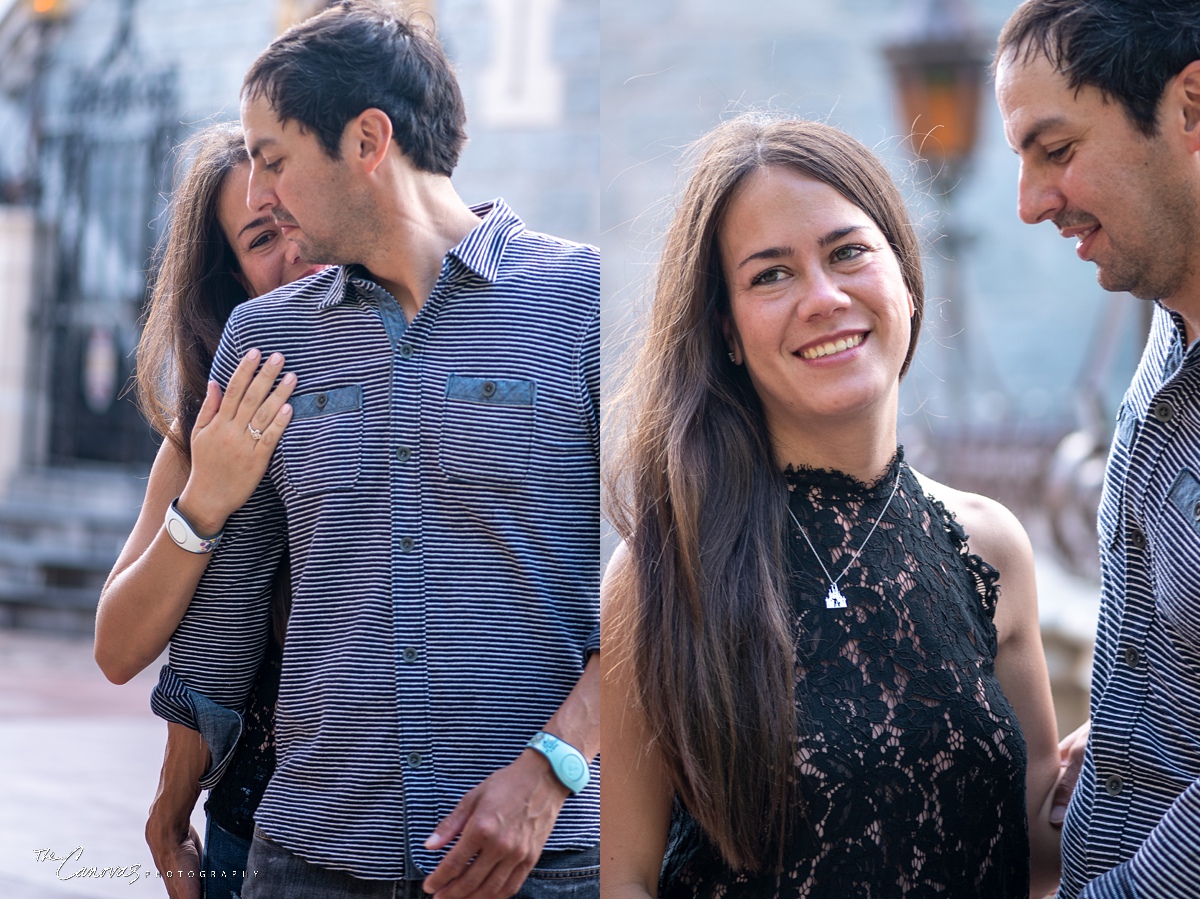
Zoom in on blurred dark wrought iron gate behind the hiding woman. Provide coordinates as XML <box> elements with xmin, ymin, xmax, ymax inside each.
<box><xmin>40</xmin><ymin>0</ymin><xmax>181</xmax><ymax>465</ymax></box>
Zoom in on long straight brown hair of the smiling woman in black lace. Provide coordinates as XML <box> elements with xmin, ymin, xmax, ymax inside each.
<box><xmin>605</xmin><ymin>114</ymin><xmax>924</xmax><ymax>869</ymax></box>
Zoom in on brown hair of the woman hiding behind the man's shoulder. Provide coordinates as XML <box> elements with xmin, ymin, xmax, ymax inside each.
<box><xmin>137</xmin><ymin>125</ymin><xmax>250</xmax><ymax>460</ymax></box>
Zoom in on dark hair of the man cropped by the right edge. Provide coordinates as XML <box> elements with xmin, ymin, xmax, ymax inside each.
<box><xmin>992</xmin><ymin>0</ymin><xmax>1200</xmax><ymax>137</ymax></box>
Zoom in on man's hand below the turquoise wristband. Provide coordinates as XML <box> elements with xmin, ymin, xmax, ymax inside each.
<box><xmin>425</xmin><ymin>749</ymin><xmax>569</xmax><ymax>899</ymax></box>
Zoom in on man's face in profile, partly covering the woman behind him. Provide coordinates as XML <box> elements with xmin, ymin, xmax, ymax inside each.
<box><xmin>241</xmin><ymin>95</ymin><xmax>361</xmax><ymax>264</ymax></box>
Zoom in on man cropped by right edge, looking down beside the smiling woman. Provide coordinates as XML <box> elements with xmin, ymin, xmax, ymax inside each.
<box><xmin>996</xmin><ymin>0</ymin><xmax>1200</xmax><ymax>899</ymax></box>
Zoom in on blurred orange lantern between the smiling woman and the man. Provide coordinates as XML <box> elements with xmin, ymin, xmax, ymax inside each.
<box><xmin>883</xmin><ymin>0</ymin><xmax>990</xmax><ymax>178</ymax></box>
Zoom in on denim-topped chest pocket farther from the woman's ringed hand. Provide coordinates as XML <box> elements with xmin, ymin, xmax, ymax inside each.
<box><xmin>438</xmin><ymin>374</ymin><xmax>538</xmax><ymax>486</ymax></box>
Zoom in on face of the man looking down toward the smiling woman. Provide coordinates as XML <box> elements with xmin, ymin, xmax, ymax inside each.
<box><xmin>996</xmin><ymin>48</ymin><xmax>1200</xmax><ymax>300</ymax></box>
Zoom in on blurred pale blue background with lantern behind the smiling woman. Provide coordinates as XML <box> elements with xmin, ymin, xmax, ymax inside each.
<box><xmin>600</xmin><ymin>0</ymin><xmax>1128</xmax><ymax>748</ymax></box>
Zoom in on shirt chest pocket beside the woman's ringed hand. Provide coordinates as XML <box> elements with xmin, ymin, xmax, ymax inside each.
<box><xmin>280</xmin><ymin>384</ymin><xmax>362</xmax><ymax>496</ymax></box>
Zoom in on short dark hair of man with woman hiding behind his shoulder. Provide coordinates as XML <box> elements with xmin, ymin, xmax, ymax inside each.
<box><xmin>241</xmin><ymin>0</ymin><xmax>467</xmax><ymax>175</ymax></box>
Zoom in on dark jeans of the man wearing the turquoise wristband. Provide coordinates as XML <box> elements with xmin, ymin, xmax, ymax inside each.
<box><xmin>242</xmin><ymin>827</ymin><xmax>600</xmax><ymax>899</ymax></box>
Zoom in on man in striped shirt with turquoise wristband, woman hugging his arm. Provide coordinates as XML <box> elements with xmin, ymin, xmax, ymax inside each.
<box><xmin>152</xmin><ymin>1</ymin><xmax>600</xmax><ymax>899</ymax></box>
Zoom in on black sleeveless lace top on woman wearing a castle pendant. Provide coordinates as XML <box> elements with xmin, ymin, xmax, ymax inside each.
<box><xmin>659</xmin><ymin>450</ymin><xmax>1030</xmax><ymax>899</ymax></box>
